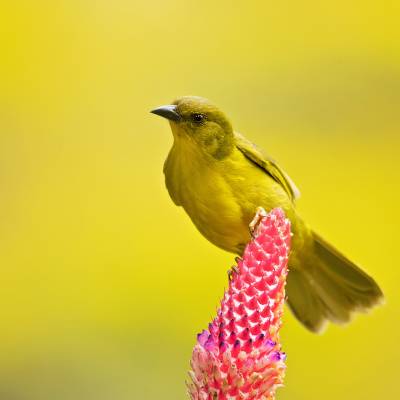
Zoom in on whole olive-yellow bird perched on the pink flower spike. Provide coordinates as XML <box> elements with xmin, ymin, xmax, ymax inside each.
<box><xmin>152</xmin><ymin>96</ymin><xmax>383</xmax><ymax>332</ymax></box>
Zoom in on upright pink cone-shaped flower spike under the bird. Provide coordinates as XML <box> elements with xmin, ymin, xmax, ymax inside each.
<box><xmin>188</xmin><ymin>208</ymin><xmax>291</xmax><ymax>400</ymax></box>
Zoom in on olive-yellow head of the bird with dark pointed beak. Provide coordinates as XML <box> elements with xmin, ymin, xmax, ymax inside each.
<box><xmin>151</xmin><ymin>96</ymin><xmax>234</xmax><ymax>159</ymax></box>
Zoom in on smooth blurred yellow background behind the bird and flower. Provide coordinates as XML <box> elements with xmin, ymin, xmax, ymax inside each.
<box><xmin>0</xmin><ymin>0</ymin><xmax>400</xmax><ymax>400</ymax></box>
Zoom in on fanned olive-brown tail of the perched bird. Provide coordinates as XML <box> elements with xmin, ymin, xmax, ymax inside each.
<box><xmin>287</xmin><ymin>233</ymin><xmax>383</xmax><ymax>332</ymax></box>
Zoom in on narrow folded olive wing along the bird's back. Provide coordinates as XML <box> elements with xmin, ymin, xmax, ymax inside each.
<box><xmin>235</xmin><ymin>132</ymin><xmax>300</xmax><ymax>201</ymax></box>
